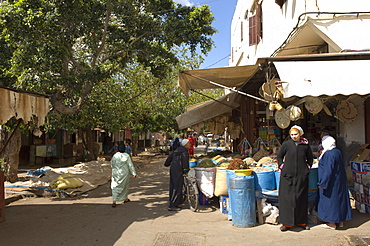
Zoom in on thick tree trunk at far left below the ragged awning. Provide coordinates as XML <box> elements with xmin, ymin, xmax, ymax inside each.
<box><xmin>5</xmin><ymin>130</ymin><xmax>21</xmax><ymax>183</ymax></box>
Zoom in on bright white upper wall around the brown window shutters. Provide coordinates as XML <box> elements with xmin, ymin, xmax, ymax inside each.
<box><xmin>229</xmin><ymin>0</ymin><xmax>370</xmax><ymax>66</ymax></box>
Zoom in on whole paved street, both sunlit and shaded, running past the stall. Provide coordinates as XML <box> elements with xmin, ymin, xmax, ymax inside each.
<box><xmin>0</xmin><ymin>145</ymin><xmax>370</xmax><ymax>246</ymax></box>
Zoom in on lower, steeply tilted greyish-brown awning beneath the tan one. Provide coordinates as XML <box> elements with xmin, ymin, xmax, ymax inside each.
<box><xmin>176</xmin><ymin>92</ymin><xmax>241</xmax><ymax>129</ymax></box>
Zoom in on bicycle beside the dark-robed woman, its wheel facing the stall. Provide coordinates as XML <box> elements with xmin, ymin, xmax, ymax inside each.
<box><xmin>182</xmin><ymin>169</ymin><xmax>199</xmax><ymax>212</ymax></box>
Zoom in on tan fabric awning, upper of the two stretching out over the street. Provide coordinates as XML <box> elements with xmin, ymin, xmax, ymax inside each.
<box><xmin>179</xmin><ymin>65</ymin><xmax>259</xmax><ymax>95</ymax></box>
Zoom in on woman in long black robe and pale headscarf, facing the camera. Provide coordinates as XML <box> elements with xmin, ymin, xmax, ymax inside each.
<box><xmin>277</xmin><ymin>125</ymin><xmax>313</xmax><ymax>231</ymax></box>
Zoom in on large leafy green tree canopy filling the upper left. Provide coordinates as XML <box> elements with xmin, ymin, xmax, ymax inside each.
<box><xmin>0</xmin><ymin>0</ymin><xmax>216</xmax><ymax>116</ymax></box>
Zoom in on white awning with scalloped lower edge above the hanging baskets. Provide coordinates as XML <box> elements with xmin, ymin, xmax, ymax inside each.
<box><xmin>274</xmin><ymin>60</ymin><xmax>370</xmax><ymax>98</ymax></box>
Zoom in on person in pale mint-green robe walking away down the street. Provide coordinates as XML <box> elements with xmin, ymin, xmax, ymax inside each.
<box><xmin>111</xmin><ymin>144</ymin><xmax>137</xmax><ymax>207</ymax></box>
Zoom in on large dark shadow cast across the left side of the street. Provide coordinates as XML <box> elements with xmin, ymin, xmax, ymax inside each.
<box><xmin>0</xmin><ymin>158</ymin><xmax>221</xmax><ymax>245</ymax></box>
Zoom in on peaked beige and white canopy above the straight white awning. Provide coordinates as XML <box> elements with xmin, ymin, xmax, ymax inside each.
<box><xmin>272</xmin><ymin>14</ymin><xmax>370</xmax><ymax>56</ymax></box>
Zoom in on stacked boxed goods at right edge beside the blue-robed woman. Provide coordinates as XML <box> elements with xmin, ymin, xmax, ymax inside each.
<box><xmin>350</xmin><ymin>144</ymin><xmax>370</xmax><ymax>214</ymax></box>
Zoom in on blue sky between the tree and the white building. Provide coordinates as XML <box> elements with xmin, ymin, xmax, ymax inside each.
<box><xmin>174</xmin><ymin>0</ymin><xmax>238</xmax><ymax>69</ymax></box>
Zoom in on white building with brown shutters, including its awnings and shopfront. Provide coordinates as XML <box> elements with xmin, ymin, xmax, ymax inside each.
<box><xmin>178</xmin><ymin>0</ymin><xmax>370</xmax><ymax>163</ymax></box>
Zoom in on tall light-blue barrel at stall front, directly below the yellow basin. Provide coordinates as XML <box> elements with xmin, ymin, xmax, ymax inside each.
<box><xmin>229</xmin><ymin>175</ymin><xmax>256</xmax><ymax>227</ymax></box>
